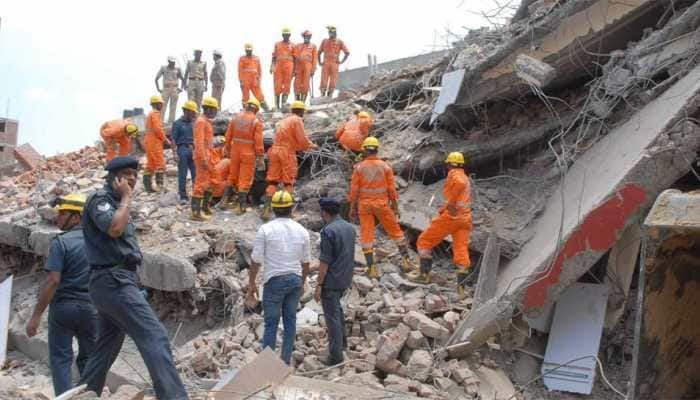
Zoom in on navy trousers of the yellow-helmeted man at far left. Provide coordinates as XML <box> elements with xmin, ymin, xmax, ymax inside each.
<box><xmin>49</xmin><ymin>300</ymin><xmax>97</xmax><ymax>396</ymax></box>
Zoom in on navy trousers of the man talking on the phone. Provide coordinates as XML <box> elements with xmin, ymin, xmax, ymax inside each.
<box><xmin>82</xmin><ymin>267</ymin><xmax>187</xmax><ymax>400</ymax></box>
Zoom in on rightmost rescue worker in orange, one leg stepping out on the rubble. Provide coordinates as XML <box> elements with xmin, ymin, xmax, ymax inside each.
<box><xmin>409</xmin><ymin>152</ymin><xmax>472</xmax><ymax>296</ymax></box>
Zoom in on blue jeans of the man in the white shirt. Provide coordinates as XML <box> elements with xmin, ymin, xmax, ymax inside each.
<box><xmin>262</xmin><ymin>274</ymin><xmax>302</xmax><ymax>365</ymax></box>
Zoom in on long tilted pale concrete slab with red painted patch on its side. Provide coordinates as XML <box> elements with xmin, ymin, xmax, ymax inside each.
<box><xmin>449</xmin><ymin>61</ymin><xmax>700</xmax><ymax>346</ymax></box>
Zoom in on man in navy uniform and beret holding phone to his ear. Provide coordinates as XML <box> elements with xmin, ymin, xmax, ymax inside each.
<box><xmin>82</xmin><ymin>157</ymin><xmax>187</xmax><ymax>400</ymax></box>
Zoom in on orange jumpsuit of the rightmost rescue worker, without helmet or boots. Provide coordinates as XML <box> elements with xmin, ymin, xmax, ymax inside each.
<box><xmin>416</xmin><ymin>168</ymin><xmax>472</xmax><ymax>269</ymax></box>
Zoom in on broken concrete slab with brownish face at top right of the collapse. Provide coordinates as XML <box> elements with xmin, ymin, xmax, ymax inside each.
<box><xmin>456</xmin><ymin>0</ymin><xmax>663</xmax><ymax>106</ymax></box>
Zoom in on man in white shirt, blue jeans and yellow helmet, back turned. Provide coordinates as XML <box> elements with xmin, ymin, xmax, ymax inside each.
<box><xmin>247</xmin><ymin>191</ymin><xmax>311</xmax><ymax>365</ymax></box>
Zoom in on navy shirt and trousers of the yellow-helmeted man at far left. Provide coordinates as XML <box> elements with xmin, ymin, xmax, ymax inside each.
<box><xmin>44</xmin><ymin>226</ymin><xmax>97</xmax><ymax>396</ymax></box>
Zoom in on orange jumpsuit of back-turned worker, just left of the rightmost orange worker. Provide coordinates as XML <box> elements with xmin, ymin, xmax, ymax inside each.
<box><xmin>348</xmin><ymin>154</ymin><xmax>404</xmax><ymax>252</ymax></box>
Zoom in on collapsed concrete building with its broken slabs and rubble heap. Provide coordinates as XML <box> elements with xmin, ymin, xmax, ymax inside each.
<box><xmin>0</xmin><ymin>0</ymin><xmax>700</xmax><ymax>399</ymax></box>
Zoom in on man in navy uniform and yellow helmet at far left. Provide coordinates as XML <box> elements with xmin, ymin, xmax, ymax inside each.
<box><xmin>27</xmin><ymin>194</ymin><xmax>97</xmax><ymax>396</ymax></box>
